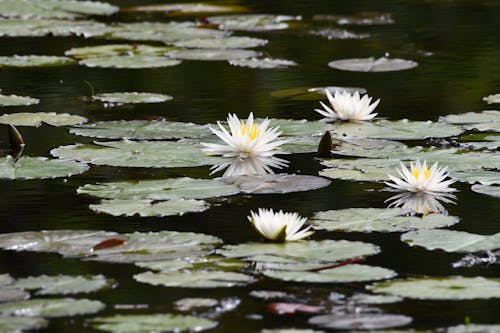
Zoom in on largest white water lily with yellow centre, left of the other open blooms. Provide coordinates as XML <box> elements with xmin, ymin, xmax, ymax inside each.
<box><xmin>201</xmin><ymin>113</ymin><xmax>288</xmax><ymax>158</ymax></box>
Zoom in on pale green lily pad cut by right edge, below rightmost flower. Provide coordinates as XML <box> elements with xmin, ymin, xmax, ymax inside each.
<box><xmin>401</xmin><ymin>230</ymin><xmax>500</xmax><ymax>253</ymax></box>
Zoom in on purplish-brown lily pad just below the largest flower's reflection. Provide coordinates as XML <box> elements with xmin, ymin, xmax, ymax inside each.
<box><xmin>220</xmin><ymin>173</ymin><xmax>330</xmax><ymax>194</ymax></box>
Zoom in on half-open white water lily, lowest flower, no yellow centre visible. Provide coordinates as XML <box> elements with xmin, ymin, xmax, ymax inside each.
<box><xmin>248</xmin><ymin>208</ymin><xmax>314</xmax><ymax>242</ymax></box>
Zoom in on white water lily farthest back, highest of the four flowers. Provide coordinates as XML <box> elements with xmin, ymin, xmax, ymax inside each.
<box><xmin>315</xmin><ymin>89</ymin><xmax>380</xmax><ymax>121</ymax></box>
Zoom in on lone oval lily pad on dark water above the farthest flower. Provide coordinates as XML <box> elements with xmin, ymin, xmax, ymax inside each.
<box><xmin>328</xmin><ymin>57</ymin><xmax>418</xmax><ymax>72</ymax></box>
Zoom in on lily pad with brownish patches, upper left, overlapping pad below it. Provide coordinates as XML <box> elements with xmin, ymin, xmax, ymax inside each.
<box><xmin>64</xmin><ymin>44</ymin><xmax>173</xmax><ymax>59</ymax></box>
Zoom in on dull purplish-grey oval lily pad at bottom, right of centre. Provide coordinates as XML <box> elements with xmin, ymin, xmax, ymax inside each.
<box><xmin>309</xmin><ymin>313</ymin><xmax>413</xmax><ymax>330</ymax></box>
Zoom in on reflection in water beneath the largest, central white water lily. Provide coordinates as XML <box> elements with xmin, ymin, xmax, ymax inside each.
<box><xmin>210</xmin><ymin>155</ymin><xmax>288</xmax><ymax>177</ymax></box>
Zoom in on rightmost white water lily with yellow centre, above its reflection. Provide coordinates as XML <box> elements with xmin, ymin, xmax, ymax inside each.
<box><xmin>385</xmin><ymin>160</ymin><xmax>456</xmax><ymax>194</ymax></box>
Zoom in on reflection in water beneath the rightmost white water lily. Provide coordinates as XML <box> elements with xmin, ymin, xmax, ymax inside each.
<box><xmin>385</xmin><ymin>192</ymin><xmax>456</xmax><ymax>215</ymax></box>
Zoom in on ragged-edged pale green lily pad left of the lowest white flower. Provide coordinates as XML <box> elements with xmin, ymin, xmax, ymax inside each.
<box><xmin>89</xmin><ymin>199</ymin><xmax>209</xmax><ymax>217</ymax></box>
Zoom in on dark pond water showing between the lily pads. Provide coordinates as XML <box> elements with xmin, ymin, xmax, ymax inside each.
<box><xmin>0</xmin><ymin>0</ymin><xmax>500</xmax><ymax>332</ymax></box>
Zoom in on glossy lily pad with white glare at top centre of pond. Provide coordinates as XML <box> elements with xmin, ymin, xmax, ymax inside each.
<box><xmin>207</xmin><ymin>14</ymin><xmax>301</xmax><ymax>31</ymax></box>
